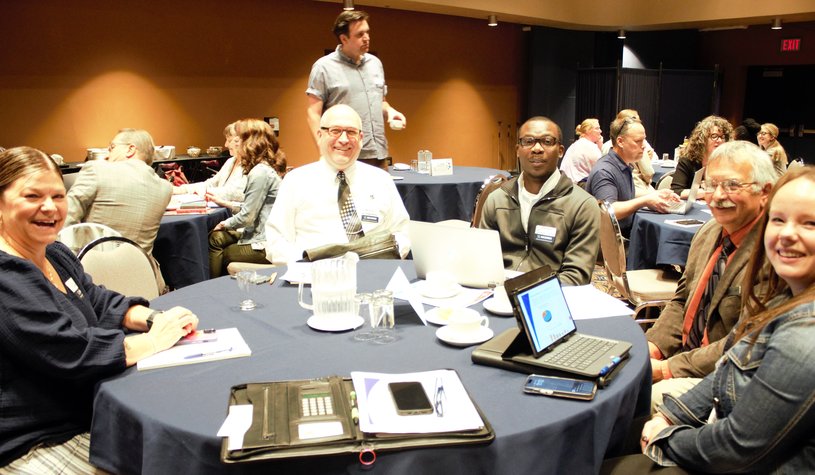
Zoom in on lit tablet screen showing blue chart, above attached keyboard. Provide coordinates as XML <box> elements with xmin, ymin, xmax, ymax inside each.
<box><xmin>514</xmin><ymin>276</ymin><xmax>577</xmax><ymax>357</ymax></box>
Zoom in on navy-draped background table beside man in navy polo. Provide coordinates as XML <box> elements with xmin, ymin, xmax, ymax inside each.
<box><xmin>626</xmin><ymin>202</ymin><xmax>712</xmax><ymax>270</ymax></box>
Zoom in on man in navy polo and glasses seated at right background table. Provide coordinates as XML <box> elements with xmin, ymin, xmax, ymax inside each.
<box><xmin>586</xmin><ymin>117</ymin><xmax>679</xmax><ymax>237</ymax></box>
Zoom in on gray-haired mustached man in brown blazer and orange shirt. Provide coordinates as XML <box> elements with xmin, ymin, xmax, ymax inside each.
<box><xmin>646</xmin><ymin>141</ymin><xmax>775</xmax><ymax>408</ymax></box>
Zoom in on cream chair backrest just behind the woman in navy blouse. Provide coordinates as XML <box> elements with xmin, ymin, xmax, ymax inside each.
<box><xmin>77</xmin><ymin>236</ymin><xmax>159</xmax><ymax>300</ymax></box>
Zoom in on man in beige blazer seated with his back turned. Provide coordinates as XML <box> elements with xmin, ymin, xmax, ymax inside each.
<box><xmin>65</xmin><ymin>129</ymin><xmax>173</xmax><ymax>289</ymax></box>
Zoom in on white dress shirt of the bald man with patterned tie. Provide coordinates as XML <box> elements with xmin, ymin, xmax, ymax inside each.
<box><xmin>266</xmin><ymin>159</ymin><xmax>410</xmax><ymax>264</ymax></box>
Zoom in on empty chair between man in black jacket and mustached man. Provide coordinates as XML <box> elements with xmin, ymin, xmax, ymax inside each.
<box><xmin>600</xmin><ymin>203</ymin><xmax>678</xmax><ymax>324</ymax></box>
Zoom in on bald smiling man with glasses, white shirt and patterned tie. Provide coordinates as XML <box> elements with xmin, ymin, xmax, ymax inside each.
<box><xmin>266</xmin><ymin>104</ymin><xmax>410</xmax><ymax>264</ymax></box>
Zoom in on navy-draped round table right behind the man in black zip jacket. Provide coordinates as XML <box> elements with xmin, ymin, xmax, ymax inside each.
<box><xmin>388</xmin><ymin>166</ymin><xmax>509</xmax><ymax>223</ymax></box>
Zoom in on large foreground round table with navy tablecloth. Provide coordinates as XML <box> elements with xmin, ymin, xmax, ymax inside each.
<box><xmin>91</xmin><ymin>260</ymin><xmax>650</xmax><ymax>475</ymax></box>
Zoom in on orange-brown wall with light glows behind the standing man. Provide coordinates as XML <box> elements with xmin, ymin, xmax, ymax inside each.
<box><xmin>0</xmin><ymin>0</ymin><xmax>524</xmax><ymax>167</ymax></box>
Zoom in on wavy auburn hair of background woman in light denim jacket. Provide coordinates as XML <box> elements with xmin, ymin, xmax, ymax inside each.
<box><xmin>235</xmin><ymin>119</ymin><xmax>286</xmax><ymax>176</ymax></box>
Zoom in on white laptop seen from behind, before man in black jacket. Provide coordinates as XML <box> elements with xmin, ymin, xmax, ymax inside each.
<box><xmin>408</xmin><ymin>221</ymin><xmax>506</xmax><ymax>289</ymax></box>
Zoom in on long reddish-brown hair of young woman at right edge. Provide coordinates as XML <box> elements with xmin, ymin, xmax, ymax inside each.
<box><xmin>734</xmin><ymin>166</ymin><xmax>815</xmax><ymax>343</ymax></box>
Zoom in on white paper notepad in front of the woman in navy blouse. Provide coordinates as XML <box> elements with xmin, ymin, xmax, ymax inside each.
<box><xmin>136</xmin><ymin>328</ymin><xmax>252</xmax><ymax>371</ymax></box>
